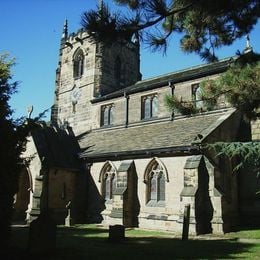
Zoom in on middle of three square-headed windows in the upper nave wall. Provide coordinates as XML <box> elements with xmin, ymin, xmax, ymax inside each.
<box><xmin>142</xmin><ymin>95</ymin><xmax>158</xmax><ymax>119</ymax></box>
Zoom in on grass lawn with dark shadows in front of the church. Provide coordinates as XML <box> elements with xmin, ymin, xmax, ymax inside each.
<box><xmin>6</xmin><ymin>225</ymin><xmax>260</xmax><ymax>260</ymax></box>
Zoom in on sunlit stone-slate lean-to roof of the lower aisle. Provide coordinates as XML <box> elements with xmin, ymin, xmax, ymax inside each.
<box><xmin>79</xmin><ymin>110</ymin><xmax>234</xmax><ymax>158</ymax></box>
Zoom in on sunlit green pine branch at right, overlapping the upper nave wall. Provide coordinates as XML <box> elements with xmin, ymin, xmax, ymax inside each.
<box><xmin>165</xmin><ymin>53</ymin><xmax>260</xmax><ymax>120</ymax></box>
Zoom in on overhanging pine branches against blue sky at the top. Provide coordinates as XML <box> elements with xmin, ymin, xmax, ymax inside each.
<box><xmin>81</xmin><ymin>0</ymin><xmax>260</xmax><ymax>61</ymax></box>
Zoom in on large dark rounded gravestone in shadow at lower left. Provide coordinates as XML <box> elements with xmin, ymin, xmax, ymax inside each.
<box><xmin>28</xmin><ymin>212</ymin><xmax>56</xmax><ymax>254</ymax></box>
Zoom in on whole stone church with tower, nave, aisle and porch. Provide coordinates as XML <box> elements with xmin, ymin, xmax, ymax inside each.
<box><xmin>14</xmin><ymin>20</ymin><xmax>260</xmax><ymax>234</ymax></box>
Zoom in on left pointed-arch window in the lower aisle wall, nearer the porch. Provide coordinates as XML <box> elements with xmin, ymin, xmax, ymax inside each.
<box><xmin>100</xmin><ymin>162</ymin><xmax>116</xmax><ymax>201</ymax></box>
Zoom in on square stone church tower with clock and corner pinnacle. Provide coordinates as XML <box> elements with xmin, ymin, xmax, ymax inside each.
<box><xmin>51</xmin><ymin>21</ymin><xmax>141</xmax><ymax>135</ymax></box>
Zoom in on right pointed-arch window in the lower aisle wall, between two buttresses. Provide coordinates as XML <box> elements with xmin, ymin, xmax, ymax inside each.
<box><xmin>144</xmin><ymin>159</ymin><xmax>168</xmax><ymax>206</ymax></box>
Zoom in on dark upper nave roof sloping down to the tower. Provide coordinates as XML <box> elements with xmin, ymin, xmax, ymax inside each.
<box><xmin>91</xmin><ymin>56</ymin><xmax>237</xmax><ymax>103</ymax></box>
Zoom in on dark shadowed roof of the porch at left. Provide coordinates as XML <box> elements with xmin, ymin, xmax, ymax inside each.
<box><xmin>31</xmin><ymin>126</ymin><xmax>80</xmax><ymax>170</ymax></box>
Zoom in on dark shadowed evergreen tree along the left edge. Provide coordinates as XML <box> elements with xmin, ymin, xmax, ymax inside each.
<box><xmin>0</xmin><ymin>55</ymin><xmax>32</xmax><ymax>252</ymax></box>
